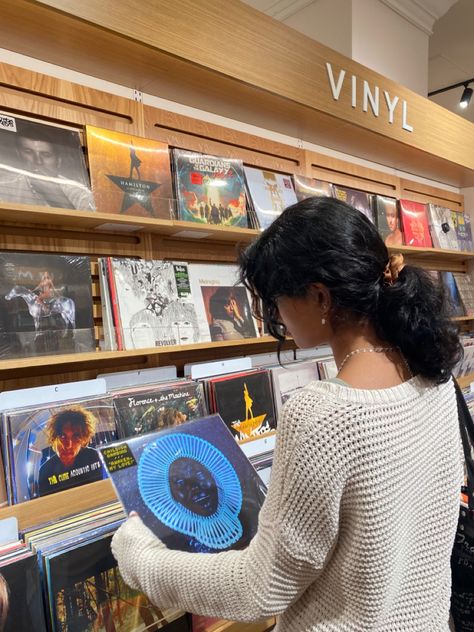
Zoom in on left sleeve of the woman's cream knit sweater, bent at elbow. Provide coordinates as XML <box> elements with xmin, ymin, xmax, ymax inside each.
<box><xmin>112</xmin><ymin>393</ymin><xmax>344</xmax><ymax>621</ymax></box>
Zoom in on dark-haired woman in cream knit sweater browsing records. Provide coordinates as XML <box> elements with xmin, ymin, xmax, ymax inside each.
<box><xmin>113</xmin><ymin>198</ymin><xmax>462</xmax><ymax>632</ymax></box>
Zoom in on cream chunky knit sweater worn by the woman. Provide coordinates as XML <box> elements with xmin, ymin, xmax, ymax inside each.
<box><xmin>112</xmin><ymin>378</ymin><xmax>462</xmax><ymax>632</ymax></box>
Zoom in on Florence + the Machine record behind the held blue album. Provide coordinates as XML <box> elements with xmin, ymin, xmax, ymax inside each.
<box><xmin>114</xmin><ymin>380</ymin><xmax>206</xmax><ymax>439</ymax></box>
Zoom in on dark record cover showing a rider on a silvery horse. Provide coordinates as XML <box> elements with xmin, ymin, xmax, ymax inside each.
<box><xmin>0</xmin><ymin>252</ymin><xmax>95</xmax><ymax>358</ymax></box>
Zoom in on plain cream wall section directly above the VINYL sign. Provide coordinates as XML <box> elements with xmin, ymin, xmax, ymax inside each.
<box><xmin>352</xmin><ymin>0</ymin><xmax>429</xmax><ymax>96</ymax></box>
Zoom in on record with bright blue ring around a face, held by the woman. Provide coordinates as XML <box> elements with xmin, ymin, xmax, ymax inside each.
<box><xmin>100</xmin><ymin>415</ymin><xmax>266</xmax><ymax>553</ymax></box>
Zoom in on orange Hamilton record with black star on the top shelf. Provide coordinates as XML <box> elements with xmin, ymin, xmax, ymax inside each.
<box><xmin>86</xmin><ymin>125</ymin><xmax>174</xmax><ymax>219</ymax></box>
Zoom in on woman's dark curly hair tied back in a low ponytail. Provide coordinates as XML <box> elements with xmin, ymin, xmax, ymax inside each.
<box><xmin>239</xmin><ymin>197</ymin><xmax>462</xmax><ymax>383</ymax></box>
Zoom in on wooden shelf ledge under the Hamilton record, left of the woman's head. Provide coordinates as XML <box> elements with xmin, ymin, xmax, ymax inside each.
<box><xmin>0</xmin><ymin>202</ymin><xmax>260</xmax><ymax>243</ymax></box>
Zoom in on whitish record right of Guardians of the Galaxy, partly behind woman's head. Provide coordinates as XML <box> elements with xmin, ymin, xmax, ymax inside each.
<box><xmin>244</xmin><ymin>167</ymin><xmax>298</xmax><ymax>230</ymax></box>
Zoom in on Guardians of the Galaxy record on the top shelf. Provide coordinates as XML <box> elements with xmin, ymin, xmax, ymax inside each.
<box><xmin>173</xmin><ymin>149</ymin><xmax>247</xmax><ymax>227</ymax></box>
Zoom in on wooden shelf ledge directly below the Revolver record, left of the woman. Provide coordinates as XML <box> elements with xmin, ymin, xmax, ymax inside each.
<box><xmin>0</xmin><ymin>336</ymin><xmax>295</xmax><ymax>379</ymax></box>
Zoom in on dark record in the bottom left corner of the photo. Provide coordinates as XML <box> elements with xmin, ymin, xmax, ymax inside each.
<box><xmin>0</xmin><ymin>553</ymin><xmax>46</xmax><ymax>632</ymax></box>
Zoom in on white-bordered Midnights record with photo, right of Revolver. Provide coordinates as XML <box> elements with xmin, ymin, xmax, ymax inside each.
<box><xmin>189</xmin><ymin>263</ymin><xmax>258</xmax><ymax>342</ymax></box>
